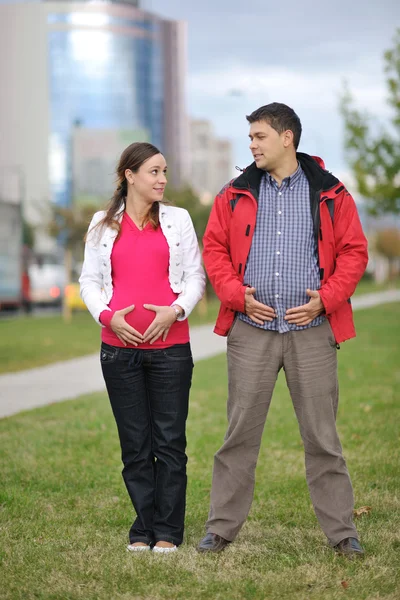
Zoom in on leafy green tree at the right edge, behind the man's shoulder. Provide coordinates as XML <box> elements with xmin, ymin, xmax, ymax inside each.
<box><xmin>340</xmin><ymin>29</ymin><xmax>400</xmax><ymax>215</ymax></box>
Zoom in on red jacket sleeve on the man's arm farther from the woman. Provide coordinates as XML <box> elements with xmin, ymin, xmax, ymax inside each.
<box><xmin>319</xmin><ymin>191</ymin><xmax>368</xmax><ymax>315</ymax></box>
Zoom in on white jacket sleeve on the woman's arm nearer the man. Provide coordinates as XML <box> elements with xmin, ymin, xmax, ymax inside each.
<box><xmin>172</xmin><ymin>211</ymin><xmax>206</xmax><ymax>321</ymax></box>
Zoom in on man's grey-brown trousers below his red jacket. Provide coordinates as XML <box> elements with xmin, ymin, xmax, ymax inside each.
<box><xmin>206</xmin><ymin>319</ymin><xmax>358</xmax><ymax>546</ymax></box>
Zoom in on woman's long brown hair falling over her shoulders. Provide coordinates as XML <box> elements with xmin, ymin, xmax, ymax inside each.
<box><xmin>89</xmin><ymin>142</ymin><xmax>160</xmax><ymax>240</ymax></box>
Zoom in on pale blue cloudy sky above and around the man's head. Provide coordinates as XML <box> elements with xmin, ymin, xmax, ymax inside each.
<box><xmin>141</xmin><ymin>0</ymin><xmax>400</xmax><ymax>188</ymax></box>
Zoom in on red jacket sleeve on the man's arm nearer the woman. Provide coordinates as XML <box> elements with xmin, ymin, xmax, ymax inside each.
<box><xmin>203</xmin><ymin>190</ymin><xmax>246</xmax><ymax>312</ymax></box>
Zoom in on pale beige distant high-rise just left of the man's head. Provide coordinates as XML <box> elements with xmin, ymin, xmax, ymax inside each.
<box><xmin>190</xmin><ymin>120</ymin><xmax>234</xmax><ymax>203</ymax></box>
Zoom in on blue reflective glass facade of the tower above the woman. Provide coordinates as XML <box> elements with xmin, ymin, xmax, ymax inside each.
<box><xmin>47</xmin><ymin>11</ymin><xmax>165</xmax><ymax>205</ymax></box>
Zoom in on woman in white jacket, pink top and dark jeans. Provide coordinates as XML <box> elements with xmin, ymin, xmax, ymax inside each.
<box><xmin>79</xmin><ymin>143</ymin><xmax>205</xmax><ymax>553</ymax></box>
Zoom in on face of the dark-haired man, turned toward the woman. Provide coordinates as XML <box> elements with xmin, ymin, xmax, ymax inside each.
<box><xmin>249</xmin><ymin>121</ymin><xmax>287</xmax><ymax>171</ymax></box>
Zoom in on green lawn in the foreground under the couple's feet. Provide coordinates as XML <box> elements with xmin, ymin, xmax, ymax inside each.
<box><xmin>0</xmin><ymin>304</ymin><xmax>400</xmax><ymax>600</ymax></box>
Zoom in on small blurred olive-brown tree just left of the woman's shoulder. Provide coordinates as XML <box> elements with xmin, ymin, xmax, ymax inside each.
<box><xmin>48</xmin><ymin>205</ymin><xmax>98</xmax><ymax>321</ymax></box>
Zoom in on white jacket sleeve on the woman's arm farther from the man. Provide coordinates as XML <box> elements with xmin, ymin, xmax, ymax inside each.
<box><xmin>79</xmin><ymin>213</ymin><xmax>110</xmax><ymax>327</ymax></box>
